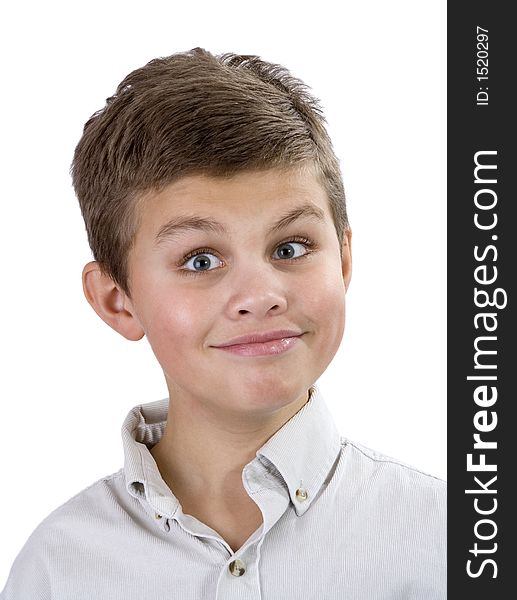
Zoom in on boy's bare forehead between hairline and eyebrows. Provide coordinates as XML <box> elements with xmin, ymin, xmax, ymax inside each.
<box><xmin>138</xmin><ymin>169</ymin><xmax>332</xmax><ymax>238</ymax></box>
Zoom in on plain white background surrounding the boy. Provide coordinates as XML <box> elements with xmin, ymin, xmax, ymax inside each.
<box><xmin>0</xmin><ymin>0</ymin><xmax>446</xmax><ymax>589</ymax></box>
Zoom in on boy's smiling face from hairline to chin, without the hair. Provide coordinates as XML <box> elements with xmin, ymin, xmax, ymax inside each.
<box><xmin>110</xmin><ymin>170</ymin><xmax>351</xmax><ymax>414</ymax></box>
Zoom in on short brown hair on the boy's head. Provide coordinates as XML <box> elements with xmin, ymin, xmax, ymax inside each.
<box><xmin>71</xmin><ymin>48</ymin><xmax>349</xmax><ymax>296</ymax></box>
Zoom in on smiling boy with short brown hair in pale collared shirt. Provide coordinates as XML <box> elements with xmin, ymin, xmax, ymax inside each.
<box><xmin>1</xmin><ymin>48</ymin><xmax>445</xmax><ymax>600</ymax></box>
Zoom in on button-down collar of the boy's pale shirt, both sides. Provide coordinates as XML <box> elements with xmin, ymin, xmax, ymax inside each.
<box><xmin>121</xmin><ymin>385</ymin><xmax>341</xmax><ymax>518</ymax></box>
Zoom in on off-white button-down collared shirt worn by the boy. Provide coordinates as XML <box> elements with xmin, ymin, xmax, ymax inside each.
<box><xmin>0</xmin><ymin>386</ymin><xmax>446</xmax><ymax>600</ymax></box>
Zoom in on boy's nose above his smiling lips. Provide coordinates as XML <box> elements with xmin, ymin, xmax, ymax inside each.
<box><xmin>223</xmin><ymin>262</ymin><xmax>288</xmax><ymax>319</ymax></box>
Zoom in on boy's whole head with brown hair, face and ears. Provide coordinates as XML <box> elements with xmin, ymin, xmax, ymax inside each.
<box><xmin>73</xmin><ymin>49</ymin><xmax>351</xmax><ymax>414</ymax></box>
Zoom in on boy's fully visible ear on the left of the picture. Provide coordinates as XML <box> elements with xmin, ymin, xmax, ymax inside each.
<box><xmin>83</xmin><ymin>261</ymin><xmax>144</xmax><ymax>341</ymax></box>
